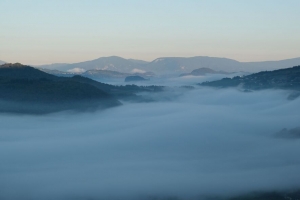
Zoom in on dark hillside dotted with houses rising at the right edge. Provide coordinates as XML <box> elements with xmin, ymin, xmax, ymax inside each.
<box><xmin>199</xmin><ymin>65</ymin><xmax>300</xmax><ymax>91</ymax></box>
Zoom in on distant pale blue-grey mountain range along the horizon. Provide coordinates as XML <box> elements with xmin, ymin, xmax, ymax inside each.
<box><xmin>33</xmin><ymin>56</ymin><xmax>300</xmax><ymax>74</ymax></box>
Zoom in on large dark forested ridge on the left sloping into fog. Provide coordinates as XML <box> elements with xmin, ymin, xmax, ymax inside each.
<box><xmin>0</xmin><ymin>63</ymin><xmax>162</xmax><ymax>114</ymax></box>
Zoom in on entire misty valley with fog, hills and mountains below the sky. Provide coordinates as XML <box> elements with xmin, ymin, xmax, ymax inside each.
<box><xmin>0</xmin><ymin>57</ymin><xmax>300</xmax><ymax>200</ymax></box>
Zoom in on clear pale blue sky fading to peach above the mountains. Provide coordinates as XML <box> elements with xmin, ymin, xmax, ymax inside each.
<box><xmin>0</xmin><ymin>0</ymin><xmax>300</xmax><ymax>64</ymax></box>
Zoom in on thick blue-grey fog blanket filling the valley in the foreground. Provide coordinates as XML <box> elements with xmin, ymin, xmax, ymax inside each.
<box><xmin>0</xmin><ymin>77</ymin><xmax>300</xmax><ymax>200</ymax></box>
